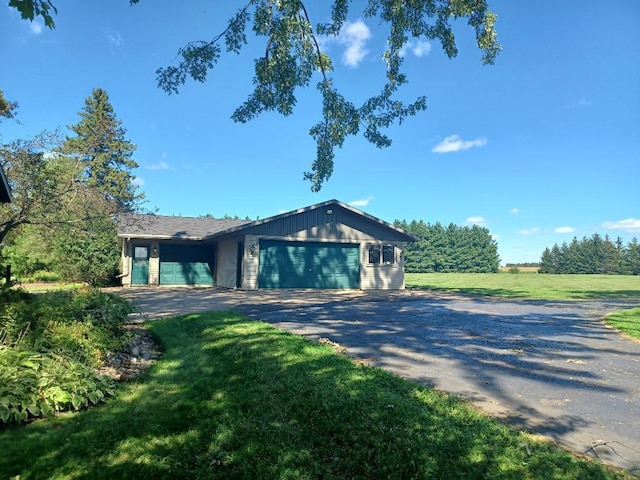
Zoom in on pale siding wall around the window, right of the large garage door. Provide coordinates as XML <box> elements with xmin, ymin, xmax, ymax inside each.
<box><xmin>360</xmin><ymin>242</ymin><xmax>404</xmax><ymax>290</ymax></box>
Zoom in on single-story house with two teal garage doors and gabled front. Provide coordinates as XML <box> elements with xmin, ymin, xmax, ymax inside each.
<box><xmin>118</xmin><ymin>200</ymin><xmax>417</xmax><ymax>290</ymax></box>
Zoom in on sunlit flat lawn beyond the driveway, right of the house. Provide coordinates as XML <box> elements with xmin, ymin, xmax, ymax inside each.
<box><xmin>405</xmin><ymin>273</ymin><xmax>640</xmax><ymax>304</ymax></box>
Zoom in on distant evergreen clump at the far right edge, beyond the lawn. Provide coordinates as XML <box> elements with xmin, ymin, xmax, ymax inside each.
<box><xmin>539</xmin><ymin>233</ymin><xmax>640</xmax><ymax>275</ymax></box>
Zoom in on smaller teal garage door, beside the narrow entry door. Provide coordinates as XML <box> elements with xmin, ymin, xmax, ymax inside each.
<box><xmin>160</xmin><ymin>243</ymin><xmax>213</xmax><ymax>285</ymax></box>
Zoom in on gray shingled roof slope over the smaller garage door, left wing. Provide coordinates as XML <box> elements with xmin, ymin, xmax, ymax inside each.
<box><xmin>118</xmin><ymin>214</ymin><xmax>251</xmax><ymax>240</ymax></box>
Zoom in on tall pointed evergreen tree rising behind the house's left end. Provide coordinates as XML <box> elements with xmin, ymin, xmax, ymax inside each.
<box><xmin>64</xmin><ymin>88</ymin><xmax>143</xmax><ymax>211</ymax></box>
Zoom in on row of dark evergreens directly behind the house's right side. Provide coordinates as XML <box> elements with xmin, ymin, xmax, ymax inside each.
<box><xmin>395</xmin><ymin>220</ymin><xmax>500</xmax><ymax>273</ymax></box>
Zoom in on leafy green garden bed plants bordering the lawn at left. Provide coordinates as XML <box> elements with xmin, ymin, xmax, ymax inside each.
<box><xmin>0</xmin><ymin>288</ymin><xmax>133</xmax><ymax>424</ymax></box>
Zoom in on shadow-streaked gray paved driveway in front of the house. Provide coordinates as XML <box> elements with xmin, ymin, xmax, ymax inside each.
<box><xmin>118</xmin><ymin>288</ymin><xmax>640</xmax><ymax>475</ymax></box>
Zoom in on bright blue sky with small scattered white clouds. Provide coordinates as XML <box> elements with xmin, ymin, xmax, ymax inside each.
<box><xmin>0</xmin><ymin>0</ymin><xmax>640</xmax><ymax>263</ymax></box>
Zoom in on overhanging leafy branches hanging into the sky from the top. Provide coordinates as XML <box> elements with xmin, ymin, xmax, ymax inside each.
<box><xmin>9</xmin><ymin>0</ymin><xmax>500</xmax><ymax>192</ymax></box>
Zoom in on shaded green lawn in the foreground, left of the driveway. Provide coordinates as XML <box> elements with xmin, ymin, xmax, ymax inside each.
<box><xmin>0</xmin><ymin>312</ymin><xmax>625</xmax><ymax>480</ymax></box>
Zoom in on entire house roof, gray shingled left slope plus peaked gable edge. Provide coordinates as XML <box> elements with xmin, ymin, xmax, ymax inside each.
<box><xmin>118</xmin><ymin>200</ymin><xmax>419</xmax><ymax>242</ymax></box>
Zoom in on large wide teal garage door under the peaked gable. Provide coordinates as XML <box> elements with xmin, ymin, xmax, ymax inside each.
<box><xmin>258</xmin><ymin>240</ymin><xmax>360</xmax><ymax>288</ymax></box>
